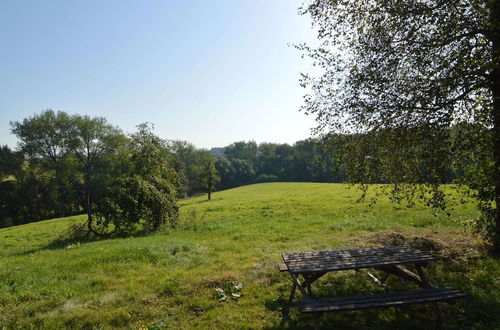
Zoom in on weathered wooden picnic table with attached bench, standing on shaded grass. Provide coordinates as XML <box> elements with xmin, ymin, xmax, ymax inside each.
<box><xmin>278</xmin><ymin>247</ymin><xmax>466</xmax><ymax>324</ymax></box>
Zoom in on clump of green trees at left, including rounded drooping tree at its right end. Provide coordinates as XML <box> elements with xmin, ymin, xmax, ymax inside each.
<box><xmin>0</xmin><ymin>110</ymin><xmax>179</xmax><ymax>235</ymax></box>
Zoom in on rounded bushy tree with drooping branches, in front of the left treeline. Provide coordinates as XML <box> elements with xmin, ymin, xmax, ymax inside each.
<box><xmin>91</xmin><ymin>123</ymin><xmax>179</xmax><ymax>236</ymax></box>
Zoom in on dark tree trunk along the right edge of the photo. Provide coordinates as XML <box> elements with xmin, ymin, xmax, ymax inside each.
<box><xmin>492</xmin><ymin>1</ymin><xmax>500</xmax><ymax>253</ymax></box>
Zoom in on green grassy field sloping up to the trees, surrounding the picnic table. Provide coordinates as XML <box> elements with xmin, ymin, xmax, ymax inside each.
<box><xmin>0</xmin><ymin>183</ymin><xmax>500</xmax><ymax>329</ymax></box>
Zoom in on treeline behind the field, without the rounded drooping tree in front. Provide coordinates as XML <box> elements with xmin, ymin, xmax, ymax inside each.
<box><xmin>0</xmin><ymin>110</ymin><xmax>345</xmax><ymax>227</ymax></box>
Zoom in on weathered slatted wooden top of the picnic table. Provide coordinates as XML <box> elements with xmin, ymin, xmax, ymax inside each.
<box><xmin>282</xmin><ymin>246</ymin><xmax>437</xmax><ymax>274</ymax></box>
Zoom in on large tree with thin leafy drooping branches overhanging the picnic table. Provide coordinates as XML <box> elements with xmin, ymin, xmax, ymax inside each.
<box><xmin>299</xmin><ymin>0</ymin><xmax>500</xmax><ymax>251</ymax></box>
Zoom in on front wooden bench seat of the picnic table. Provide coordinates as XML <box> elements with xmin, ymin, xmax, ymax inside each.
<box><xmin>297</xmin><ymin>288</ymin><xmax>467</xmax><ymax>313</ymax></box>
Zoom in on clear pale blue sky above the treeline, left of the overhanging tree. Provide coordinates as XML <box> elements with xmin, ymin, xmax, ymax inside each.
<box><xmin>0</xmin><ymin>0</ymin><xmax>315</xmax><ymax>148</ymax></box>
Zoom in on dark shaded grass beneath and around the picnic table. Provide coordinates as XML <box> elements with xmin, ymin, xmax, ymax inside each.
<box><xmin>265</xmin><ymin>256</ymin><xmax>500</xmax><ymax>330</ymax></box>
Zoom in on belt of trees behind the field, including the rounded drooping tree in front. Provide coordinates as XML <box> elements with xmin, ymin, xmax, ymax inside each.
<box><xmin>0</xmin><ymin>110</ymin><xmax>344</xmax><ymax>228</ymax></box>
